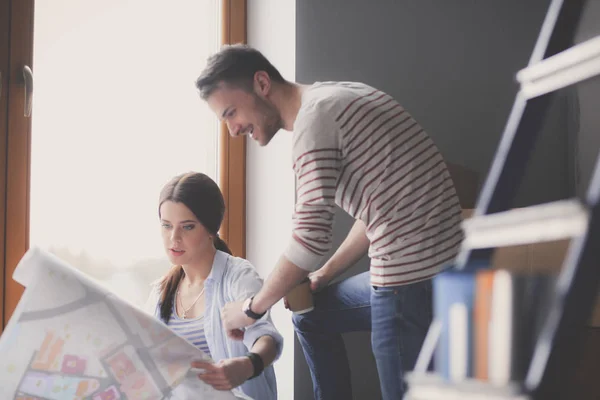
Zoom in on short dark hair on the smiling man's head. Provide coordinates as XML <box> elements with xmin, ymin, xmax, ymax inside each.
<box><xmin>196</xmin><ymin>44</ymin><xmax>285</xmax><ymax>100</ymax></box>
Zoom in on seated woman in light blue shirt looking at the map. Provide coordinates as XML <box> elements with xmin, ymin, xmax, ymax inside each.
<box><xmin>149</xmin><ymin>173</ymin><xmax>283</xmax><ymax>400</ymax></box>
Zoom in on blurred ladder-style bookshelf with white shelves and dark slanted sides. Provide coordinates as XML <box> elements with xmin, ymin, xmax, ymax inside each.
<box><xmin>405</xmin><ymin>0</ymin><xmax>600</xmax><ymax>400</ymax></box>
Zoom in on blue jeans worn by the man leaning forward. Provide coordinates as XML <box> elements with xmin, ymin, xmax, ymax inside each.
<box><xmin>293</xmin><ymin>272</ymin><xmax>432</xmax><ymax>400</ymax></box>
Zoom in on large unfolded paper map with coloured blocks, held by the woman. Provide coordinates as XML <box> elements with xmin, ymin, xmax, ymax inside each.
<box><xmin>0</xmin><ymin>248</ymin><xmax>248</xmax><ymax>400</ymax></box>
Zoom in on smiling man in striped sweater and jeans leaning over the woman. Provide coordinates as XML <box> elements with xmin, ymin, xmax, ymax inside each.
<box><xmin>196</xmin><ymin>45</ymin><xmax>462</xmax><ymax>399</ymax></box>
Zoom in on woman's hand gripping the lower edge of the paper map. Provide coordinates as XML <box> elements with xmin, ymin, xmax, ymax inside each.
<box><xmin>192</xmin><ymin>357</ymin><xmax>254</xmax><ymax>390</ymax></box>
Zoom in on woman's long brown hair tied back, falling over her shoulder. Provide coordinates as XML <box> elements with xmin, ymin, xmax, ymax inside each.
<box><xmin>158</xmin><ymin>172</ymin><xmax>231</xmax><ymax>323</ymax></box>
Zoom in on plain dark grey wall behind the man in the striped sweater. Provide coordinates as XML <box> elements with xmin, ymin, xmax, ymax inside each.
<box><xmin>294</xmin><ymin>0</ymin><xmax>577</xmax><ymax>400</ymax></box>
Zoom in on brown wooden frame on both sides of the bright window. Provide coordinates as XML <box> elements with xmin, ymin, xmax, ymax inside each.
<box><xmin>0</xmin><ymin>0</ymin><xmax>246</xmax><ymax>331</ymax></box>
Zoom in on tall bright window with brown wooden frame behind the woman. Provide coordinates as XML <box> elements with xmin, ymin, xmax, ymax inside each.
<box><xmin>0</xmin><ymin>0</ymin><xmax>245</xmax><ymax>328</ymax></box>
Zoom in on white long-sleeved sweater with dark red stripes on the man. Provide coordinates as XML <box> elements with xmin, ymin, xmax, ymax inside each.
<box><xmin>285</xmin><ymin>82</ymin><xmax>463</xmax><ymax>286</ymax></box>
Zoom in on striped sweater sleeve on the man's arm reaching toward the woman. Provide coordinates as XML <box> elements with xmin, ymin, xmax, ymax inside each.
<box><xmin>284</xmin><ymin>104</ymin><xmax>341</xmax><ymax>271</ymax></box>
